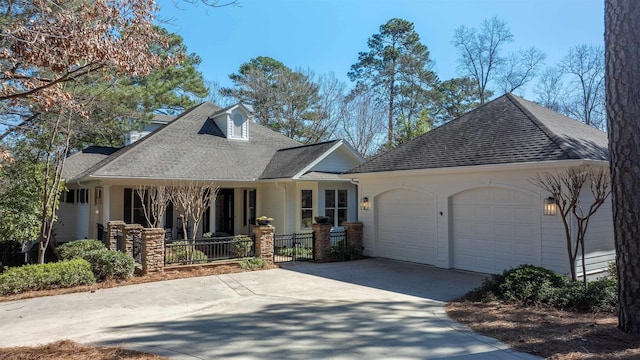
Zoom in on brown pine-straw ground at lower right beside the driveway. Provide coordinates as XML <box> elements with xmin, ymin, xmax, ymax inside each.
<box><xmin>447</xmin><ymin>300</ymin><xmax>640</xmax><ymax>360</ymax></box>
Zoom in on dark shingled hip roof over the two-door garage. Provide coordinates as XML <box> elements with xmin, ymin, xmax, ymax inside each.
<box><xmin>347</xmin><ymin>94</ymin><xmax>608</xmax><ymax>174</ymax></box>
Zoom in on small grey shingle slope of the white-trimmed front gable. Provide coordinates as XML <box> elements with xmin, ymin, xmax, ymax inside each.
<box><xmin>260</xmin><ymin>140</ymin><xmax>340</xmax><ymax>179</ymax></box>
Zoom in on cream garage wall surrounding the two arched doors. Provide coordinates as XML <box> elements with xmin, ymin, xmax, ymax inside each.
<box><xmin>358</xmin><ymin>164</ymin><xmax>614</xmax><ymax>274</ymax></box>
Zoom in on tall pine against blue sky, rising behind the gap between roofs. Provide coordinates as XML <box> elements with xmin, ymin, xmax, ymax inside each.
<box><xmin>348</xmin><ymin>18</ymin><xmax>437</xmax><ymax>147</ymax></box>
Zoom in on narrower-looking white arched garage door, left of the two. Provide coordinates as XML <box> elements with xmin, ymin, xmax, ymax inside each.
<box><xmin>375</xmin><ymin>189</ymin><xmax>436</xmax><ymax>265</ymax></box>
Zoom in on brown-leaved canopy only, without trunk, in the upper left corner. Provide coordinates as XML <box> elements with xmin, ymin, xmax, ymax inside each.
<box><xmin>0</xmin><ymin>0</ymin><xmax>179</xmax><ymax>117</ymax></box>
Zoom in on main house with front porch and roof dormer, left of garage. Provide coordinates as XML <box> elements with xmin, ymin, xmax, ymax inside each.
<box><xmin>56</xmin><ymin>102</ymin><xmax>364</xmax><ymax>241</ymax></box>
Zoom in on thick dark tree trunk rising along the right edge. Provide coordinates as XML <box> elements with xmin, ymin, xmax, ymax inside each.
<box><xmin>605</xmin><ymin>0</ymin><xmax>640</xmax><ymax>334</ymax></box>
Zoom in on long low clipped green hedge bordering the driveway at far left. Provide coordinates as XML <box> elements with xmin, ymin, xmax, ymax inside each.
<box><xmin>0</xmin><ymin>259</ymin><xmax>96</xmax><ymax>295</ymax></box>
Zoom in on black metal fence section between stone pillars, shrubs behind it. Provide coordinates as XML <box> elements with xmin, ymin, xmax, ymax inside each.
<box><xmin>164</xmin><ymin>235</ymin><xmax>255</xmax><ymax>265</ymax></box>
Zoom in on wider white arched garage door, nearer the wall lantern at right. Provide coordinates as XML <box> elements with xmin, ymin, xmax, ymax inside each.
<box><xmin>452</xmin><ymin>188</ymin><xmax>541</xmax><ymax>273</ymax></box>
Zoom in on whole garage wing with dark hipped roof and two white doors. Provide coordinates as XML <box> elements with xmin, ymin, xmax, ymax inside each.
<box><xmin>343</xmin><ymin>94</ymin><xmax>614</xmax><ymax>275</ymax></box>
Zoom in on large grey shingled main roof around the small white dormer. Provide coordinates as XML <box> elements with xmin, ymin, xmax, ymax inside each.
<box><xmin>67</xmin><ymin>102</ymin><xmax>300</xmax><ymax>181</ymax></box>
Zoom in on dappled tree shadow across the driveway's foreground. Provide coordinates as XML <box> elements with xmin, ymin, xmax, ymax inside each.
<box><xmin>98</xmin><ymin>300</ymin><xmax>514</xmax><ymax>359</ymax></box>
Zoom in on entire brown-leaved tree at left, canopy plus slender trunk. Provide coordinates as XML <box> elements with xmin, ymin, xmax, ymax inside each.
<box><xmin>0</xmin><ymin>0</ymin><xmax>184</xmax><ymax>262</ymax></box>
